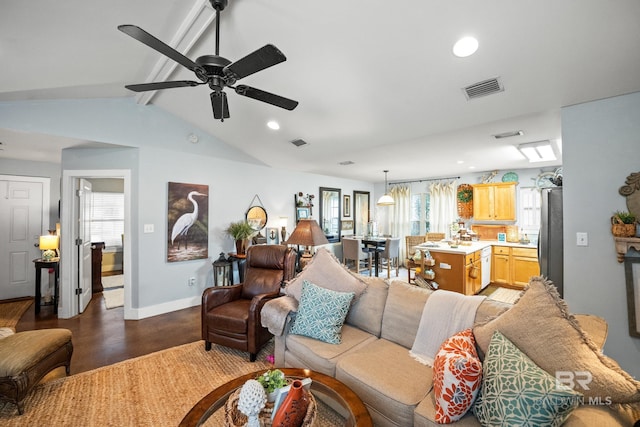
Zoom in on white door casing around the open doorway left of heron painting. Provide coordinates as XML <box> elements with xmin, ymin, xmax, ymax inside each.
<box><xmin>58</xmin><ymin>169</ymin><xmax>135</xmax><ymax>319</ymax></box>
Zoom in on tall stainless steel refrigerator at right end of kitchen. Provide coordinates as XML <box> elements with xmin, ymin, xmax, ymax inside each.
<box><xmin>538</xmin><ymin>187</ymin><xmax>564</xmax><ymax>297</ymax></box>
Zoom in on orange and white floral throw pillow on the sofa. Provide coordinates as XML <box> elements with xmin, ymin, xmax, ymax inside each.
<box><xmin>433</xmin><ymin>329</ymin><xmax>482</xmax><ymax>424</ymax></box>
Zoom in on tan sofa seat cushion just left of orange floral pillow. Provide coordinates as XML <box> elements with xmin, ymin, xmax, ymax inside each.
<box><xmin>336</xmin><ymin>339</ymin><xmax>432</xmax><ymax>426</ymax></box>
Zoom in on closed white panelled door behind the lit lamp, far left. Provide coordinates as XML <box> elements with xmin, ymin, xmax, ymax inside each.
<box><xmin>0</xmin><ymin>175</ymin><xmax>49</xmax><ymax>300</ymax></box>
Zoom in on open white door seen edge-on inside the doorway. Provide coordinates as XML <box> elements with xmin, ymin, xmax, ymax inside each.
<box><xmin>76</xmin><ymin>179</ymin><xmax>92</xmax><ymax>313</ymax></box>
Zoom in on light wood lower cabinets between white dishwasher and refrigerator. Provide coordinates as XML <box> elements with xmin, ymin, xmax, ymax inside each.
<box><xmin>491</xmin><ymin>246</ymin><xmax>540</xmax><ymax>289</ymax></box>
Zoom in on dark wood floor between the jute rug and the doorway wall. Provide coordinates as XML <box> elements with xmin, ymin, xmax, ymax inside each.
<box><xmin>16</xmin><ymin>293</ymin><xmax>200</xmax><ymax>374</ymax></box>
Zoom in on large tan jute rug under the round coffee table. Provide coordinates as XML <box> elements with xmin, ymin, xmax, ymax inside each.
<box><xmin>0</xmin><ymin>341</ymin><xmax>344</xmax><ymax>427</ymax></box>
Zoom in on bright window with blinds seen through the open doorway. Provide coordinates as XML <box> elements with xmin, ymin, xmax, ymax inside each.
<box><xmin>91</xmin><ymin>192</ymin><xmax>124</xmax><ymax>247</ymax></box>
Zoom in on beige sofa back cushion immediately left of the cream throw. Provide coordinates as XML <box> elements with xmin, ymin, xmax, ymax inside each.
<box><xmin>380</xmin><ymin>280</ymin><xmax>433</xmax><ymax>349</ymax></box>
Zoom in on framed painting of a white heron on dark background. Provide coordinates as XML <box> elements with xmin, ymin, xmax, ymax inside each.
<box><xmin>167</xmin><ymin>182</ymin><xmax>209</xmax><ymax>262</ymax></box>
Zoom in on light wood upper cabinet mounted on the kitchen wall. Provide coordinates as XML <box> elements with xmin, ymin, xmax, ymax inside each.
<box><xmin>473</xmin><ymin>182</ymin><xmax>517</xmax><ymax>221</ymax></box>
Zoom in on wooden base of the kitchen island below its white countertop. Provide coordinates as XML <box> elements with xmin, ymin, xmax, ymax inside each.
<box><xmin>431</xmin><ymin>250</ymin><xmax>482</xmax><ymax>295</ymax></box>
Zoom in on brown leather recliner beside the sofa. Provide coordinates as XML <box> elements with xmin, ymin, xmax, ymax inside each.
<box><xmin>202</xmin><ymin>245</ymin><xmax>297</xmax><ymax>362</ymax></box>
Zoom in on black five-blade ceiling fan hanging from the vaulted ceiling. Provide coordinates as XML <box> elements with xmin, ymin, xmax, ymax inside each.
<box><xmin>118</xmin><ymin>0</ymin><xmax>298</xmax><ymax>121</ymax></box>
